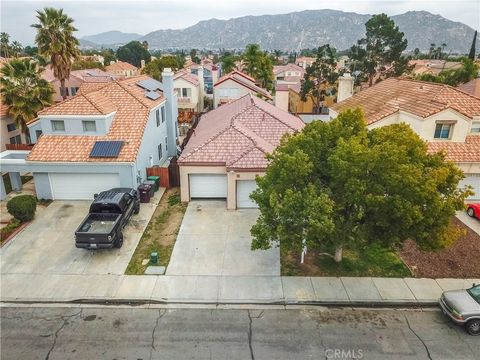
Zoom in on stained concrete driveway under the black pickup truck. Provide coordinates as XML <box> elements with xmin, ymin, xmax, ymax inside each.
<box><xmin>0</xmin><ymin>201</ymin><xmax>156</xmax><ymax>275</ymax></box>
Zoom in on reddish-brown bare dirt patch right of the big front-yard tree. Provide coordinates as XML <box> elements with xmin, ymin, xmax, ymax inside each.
<box><xmin>399</xmin><ymin>218</ymin><xmax>480</xmax><ymax>278</ymax></box>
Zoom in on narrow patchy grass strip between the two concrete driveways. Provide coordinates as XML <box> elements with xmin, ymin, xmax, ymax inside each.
<box><xmin>125</xmin><ymin>188</ymin><xmax>187</xmax><ymax>275</ymax></box>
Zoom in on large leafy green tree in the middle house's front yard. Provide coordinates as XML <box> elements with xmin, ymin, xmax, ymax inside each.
<box><xmin>251</xmin><ymin>109</ymin><xmax>470</xmax><ymax>262</ymax></box>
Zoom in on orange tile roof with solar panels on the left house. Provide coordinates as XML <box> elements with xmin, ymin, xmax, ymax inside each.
<box><xmin>27</xmin><ymin>75</ymin><xmax>165</xmax><ymax>162</ymax></box>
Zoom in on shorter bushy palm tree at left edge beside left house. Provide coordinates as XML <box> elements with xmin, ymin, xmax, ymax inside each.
<box><xmin>0</xmin><ymin>59</ymin><xmax>53</xmax><ymax>134</ymax></box>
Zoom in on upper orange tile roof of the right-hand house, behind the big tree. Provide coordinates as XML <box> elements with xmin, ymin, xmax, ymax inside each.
<box><xmin>331</xmin><ymin>78</ymin><xmax>480</xmax><ymax>124</ymax></box>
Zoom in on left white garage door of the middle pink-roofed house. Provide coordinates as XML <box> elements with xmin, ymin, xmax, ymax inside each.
<box><xmin>189</xmin><ymin>174</ymin><xmax>227</xmax><ymax>199</ymax></box>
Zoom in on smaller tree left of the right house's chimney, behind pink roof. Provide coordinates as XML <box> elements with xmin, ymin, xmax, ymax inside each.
<box><xmin>300</xmin><ymin>44</ymin><xmax>338</xmax><ymax>114</ymax></box>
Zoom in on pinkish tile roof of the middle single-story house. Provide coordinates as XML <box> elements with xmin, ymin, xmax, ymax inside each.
<box><xmin>178</xmin><ymin>94</ymin><xmax>304</xmax><ymax>170</ymax></box>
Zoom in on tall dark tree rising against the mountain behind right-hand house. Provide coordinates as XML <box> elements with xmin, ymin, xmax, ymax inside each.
<box><xmin>349</xmin><ymin>14</ymin><xmax>407</xmax><ymax>86</ymax></box>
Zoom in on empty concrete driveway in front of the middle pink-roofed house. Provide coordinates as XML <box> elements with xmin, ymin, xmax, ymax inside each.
<box><xmin>167</xmin><ymin>200</ymin><xmax>280</xmax><ymax>276</ymax></box>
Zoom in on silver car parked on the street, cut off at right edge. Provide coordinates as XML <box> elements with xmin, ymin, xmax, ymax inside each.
<box><xmin>440</xmin><ymin>284</ymin><xmax>480</xmax><ymax>335</ymax></box>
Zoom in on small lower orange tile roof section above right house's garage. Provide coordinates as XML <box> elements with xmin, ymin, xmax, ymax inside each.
<box><xmin>428</xmin><ymin>135</ymin><xmax>480</xmax><ymax>163</ymax></box>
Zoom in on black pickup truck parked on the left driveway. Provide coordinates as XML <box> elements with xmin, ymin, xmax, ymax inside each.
<box><xmin>75</xmin><ymin>188</ymin><xmax>140</xmax><ymax>249</ymax></box>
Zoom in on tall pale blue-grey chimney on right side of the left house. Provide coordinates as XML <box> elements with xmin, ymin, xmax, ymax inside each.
<box><xmin>162</xmin><ymin>68</ymin><xmax>178</xmax><ymax>157</ymax></box>
